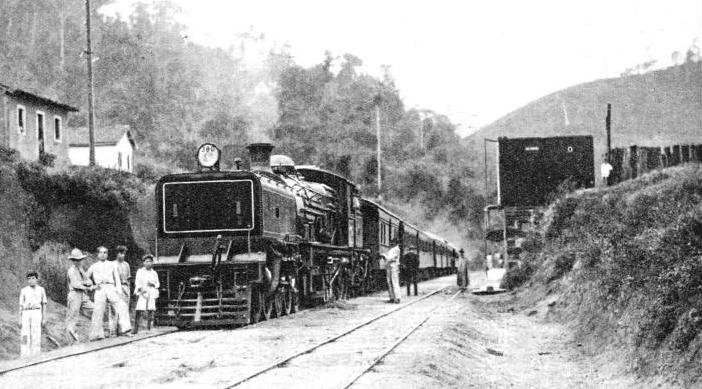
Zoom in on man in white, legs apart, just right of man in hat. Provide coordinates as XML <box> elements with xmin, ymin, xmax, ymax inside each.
<box><xmin>86</xmin><ymin>246</ymin><xmax>132</xmax><ymax>340</ymax></box>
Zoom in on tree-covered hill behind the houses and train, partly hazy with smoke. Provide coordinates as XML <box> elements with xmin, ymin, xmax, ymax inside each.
<box><xmin>0</xmin><ymin>0</ymin><xmax>484</xmax><ymax>243</ymax></box>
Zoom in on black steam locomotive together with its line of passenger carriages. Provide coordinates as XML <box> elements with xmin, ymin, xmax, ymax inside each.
<box><xmin>154</xmin><ymin>143</ymin><xmax>457</xmax><ymax>328</ymax></box>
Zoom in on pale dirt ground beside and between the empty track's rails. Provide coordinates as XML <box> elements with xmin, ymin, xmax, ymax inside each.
<box><xmin>0</xmin><ymin>273</ymin><xmax>652</xmax><ymax>389</ymax></box>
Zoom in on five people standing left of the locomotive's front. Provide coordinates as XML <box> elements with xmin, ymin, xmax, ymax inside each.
<box><xmin>19</xmin><ymin>246</ymin><xmax>160</xmax><ymax>356</ymax></box>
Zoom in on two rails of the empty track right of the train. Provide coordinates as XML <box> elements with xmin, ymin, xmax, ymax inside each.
<box><xmin>223</xmin><ymin>287</ymin><xmax>461</xmax><ymax>389</ymax></box>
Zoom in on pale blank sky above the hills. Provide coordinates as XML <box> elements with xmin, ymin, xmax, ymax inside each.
<box><xmin>103</xmin><ymin>0</ymin><xmax>702</xmax><ymax>135</ymax></box>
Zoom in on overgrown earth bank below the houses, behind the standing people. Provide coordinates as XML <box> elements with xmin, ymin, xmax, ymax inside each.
<box><xmin>0</xmin><ymin>147</ymin><xmax>153</xmax><ymax>360</ymax></box>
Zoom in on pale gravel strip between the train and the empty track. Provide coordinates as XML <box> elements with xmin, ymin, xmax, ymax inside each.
<box><xmin>0</xmin><ymin>276</ymin><xmax>455</xmax><ymax>389</ymax></box>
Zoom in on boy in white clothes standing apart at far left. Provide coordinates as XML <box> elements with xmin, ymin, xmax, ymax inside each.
<box><xmin>19</xmin><ymin>271</ymin><xmax>47</xmax><ymax>357</ymax></box>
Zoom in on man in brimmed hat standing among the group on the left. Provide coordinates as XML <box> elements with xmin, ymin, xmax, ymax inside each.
<box><xmin>66</xmin><ymin>248</ymin><xmax>94</xmax><ymax>340</ymax></box>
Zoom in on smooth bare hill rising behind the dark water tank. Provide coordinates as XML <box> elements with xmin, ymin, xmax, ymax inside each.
<box><xmin>464</xmin><ymin>62</ymin><xmax>702</xmax><ymax>192</ymax></box>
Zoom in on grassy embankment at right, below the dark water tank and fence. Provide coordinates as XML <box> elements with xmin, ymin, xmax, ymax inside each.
<box><xmin>503</xmin><ymin>164</ymin><xmax>702</xmax><ymax>387</ymax></box>
